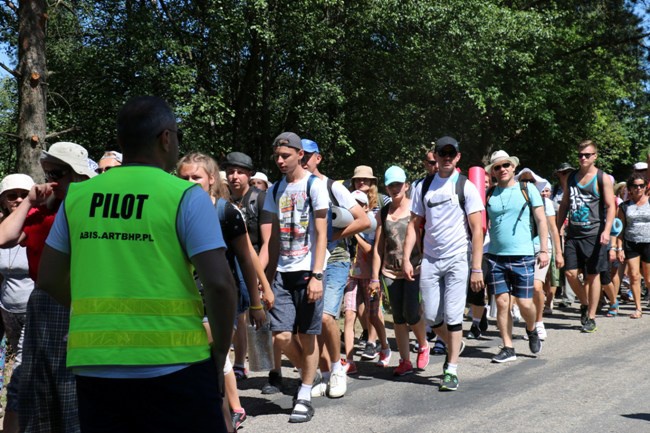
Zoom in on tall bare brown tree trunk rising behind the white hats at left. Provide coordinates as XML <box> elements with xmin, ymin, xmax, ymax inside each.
<box><xmin>18</xmin><ymin>0</ymin><xmax>47</xmax><ymax>182</ymax></box>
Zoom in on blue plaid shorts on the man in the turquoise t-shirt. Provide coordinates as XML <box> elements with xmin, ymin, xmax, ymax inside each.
<box><xmin>487</xmin><ymin>254</ymin><xmax>535</xmax><ymax>299</ymax></box>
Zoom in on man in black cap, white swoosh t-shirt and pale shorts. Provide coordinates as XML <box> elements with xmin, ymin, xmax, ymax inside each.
<box><xmin>403</xmin><ymin>137</ymin><xmax>484</xmax><ymax>391</ymax></box>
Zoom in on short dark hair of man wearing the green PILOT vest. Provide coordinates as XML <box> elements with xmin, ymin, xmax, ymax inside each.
<box><xmin>117</xmin><ymin>96</ymin><xmax>176</xmax><ymax>152</ymax></box>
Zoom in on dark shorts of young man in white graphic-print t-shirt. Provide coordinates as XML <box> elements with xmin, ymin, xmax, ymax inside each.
<box><xmin>269</xmin><ymin>271</ymin><xmax>325</xmax><ymax>335</ymax></box>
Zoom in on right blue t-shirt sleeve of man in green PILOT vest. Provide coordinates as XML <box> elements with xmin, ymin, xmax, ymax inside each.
<box><xmin>176</xmin><ymin>187</ymin><xmax>226</xmax><ymax>258</ymax></box>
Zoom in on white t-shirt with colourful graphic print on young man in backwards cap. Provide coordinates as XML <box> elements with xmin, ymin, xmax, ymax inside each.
<box><xmin>264</xmin><ymin>172</ymin><xmax>330</xmax><ymax>272</ymax></box>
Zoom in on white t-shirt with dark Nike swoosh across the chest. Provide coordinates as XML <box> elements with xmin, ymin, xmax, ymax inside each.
<box><xmin>411</xmin><ymin>173</ymin><xmax>484</xmax><ymax>259</ymax></box>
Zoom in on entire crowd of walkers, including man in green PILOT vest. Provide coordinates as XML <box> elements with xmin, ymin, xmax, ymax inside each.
<box><xmin>0</xmin><ymin>97</ymin><xmax>650</xmax><ymax>433</ymax></box>
